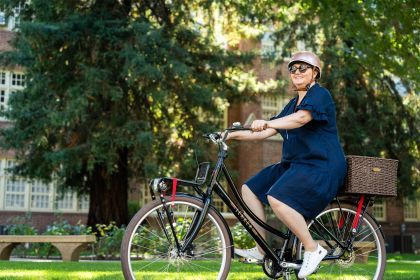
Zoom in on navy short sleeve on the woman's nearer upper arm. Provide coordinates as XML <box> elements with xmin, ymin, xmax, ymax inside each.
<box><xmin>296</xmin><ymin>86</ymin><xmax>334</xmax><ymax>123</ymax></box>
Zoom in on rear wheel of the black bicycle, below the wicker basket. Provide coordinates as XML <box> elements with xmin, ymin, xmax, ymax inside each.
<box><xmin>297</xmin><ymin>205</ymin><xmax>386</xmax><ymax>280</ymax></box>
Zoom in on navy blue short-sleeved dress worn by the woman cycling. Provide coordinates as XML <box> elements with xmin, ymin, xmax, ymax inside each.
<box><xmin>245</xmin><ymin>84</ymin><xmax>347</xmax><ymax>219</ymax></box>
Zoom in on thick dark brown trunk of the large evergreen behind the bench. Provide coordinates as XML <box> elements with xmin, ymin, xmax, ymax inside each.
<box><xmin>87</xmin><ymin>151</ymin><xmax>128</xmax><ymax>229</ymax></box>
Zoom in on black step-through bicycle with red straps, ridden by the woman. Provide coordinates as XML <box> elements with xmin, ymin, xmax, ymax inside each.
<box><xmin>121</xmin><ymin>124</ymin><xmax>386</xmax><ymax>279</ymax></box>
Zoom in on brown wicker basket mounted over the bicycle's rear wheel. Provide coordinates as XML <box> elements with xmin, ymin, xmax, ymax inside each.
<box><xmin>341</xmin><ymin>156</ymin><xmax>398</xmax><ymax>196</ymax></box>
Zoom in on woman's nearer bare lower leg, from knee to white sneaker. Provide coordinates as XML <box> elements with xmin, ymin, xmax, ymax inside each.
<box><xmin>267</xmin><ymin>195</ymin><xmax>318</xmax><ymax>251</ymax></box>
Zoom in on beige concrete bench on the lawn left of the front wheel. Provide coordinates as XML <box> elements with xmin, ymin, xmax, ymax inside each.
<box><xmin>0</xmin><ymin>235</ymin><xmax>96</xmax><ymax>261</ymax></box>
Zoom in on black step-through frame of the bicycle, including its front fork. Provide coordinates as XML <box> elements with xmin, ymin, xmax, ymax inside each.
<box><xmin>150</xmin><ymin>131</ymin><xmax>371</xmax><ymax>264</ymax></box>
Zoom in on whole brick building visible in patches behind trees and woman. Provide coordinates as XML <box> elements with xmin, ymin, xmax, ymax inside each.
<box><xmin>0</xmin><ymin>9</ymin><xmax>420</xmax><ymax>251</ymax></box>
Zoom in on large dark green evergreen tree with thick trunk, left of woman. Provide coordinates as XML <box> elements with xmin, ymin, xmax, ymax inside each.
<box><xmin>0</xmin><ymin>0</ymin><xmax>266</xmax><ymax>226</ymax></box>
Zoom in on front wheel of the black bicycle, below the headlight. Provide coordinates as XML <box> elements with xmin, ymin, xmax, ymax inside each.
<box><xmin>121</xmin><ymin>196</ymin><xmax>232</xmax><ymax>280</ymax></box>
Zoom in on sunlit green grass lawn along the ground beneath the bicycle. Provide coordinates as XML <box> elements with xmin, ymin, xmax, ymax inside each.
<box><xmin>0</xmin><ymin>255</ymin><xmax>420</xmax><ymax>280</ymax></box>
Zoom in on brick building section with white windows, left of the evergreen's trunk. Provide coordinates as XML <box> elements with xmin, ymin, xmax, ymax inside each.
<box><xmin>0</xmin><ymin>10</ymin><xmax>89</xmax><ymax>234</ymax></box>
